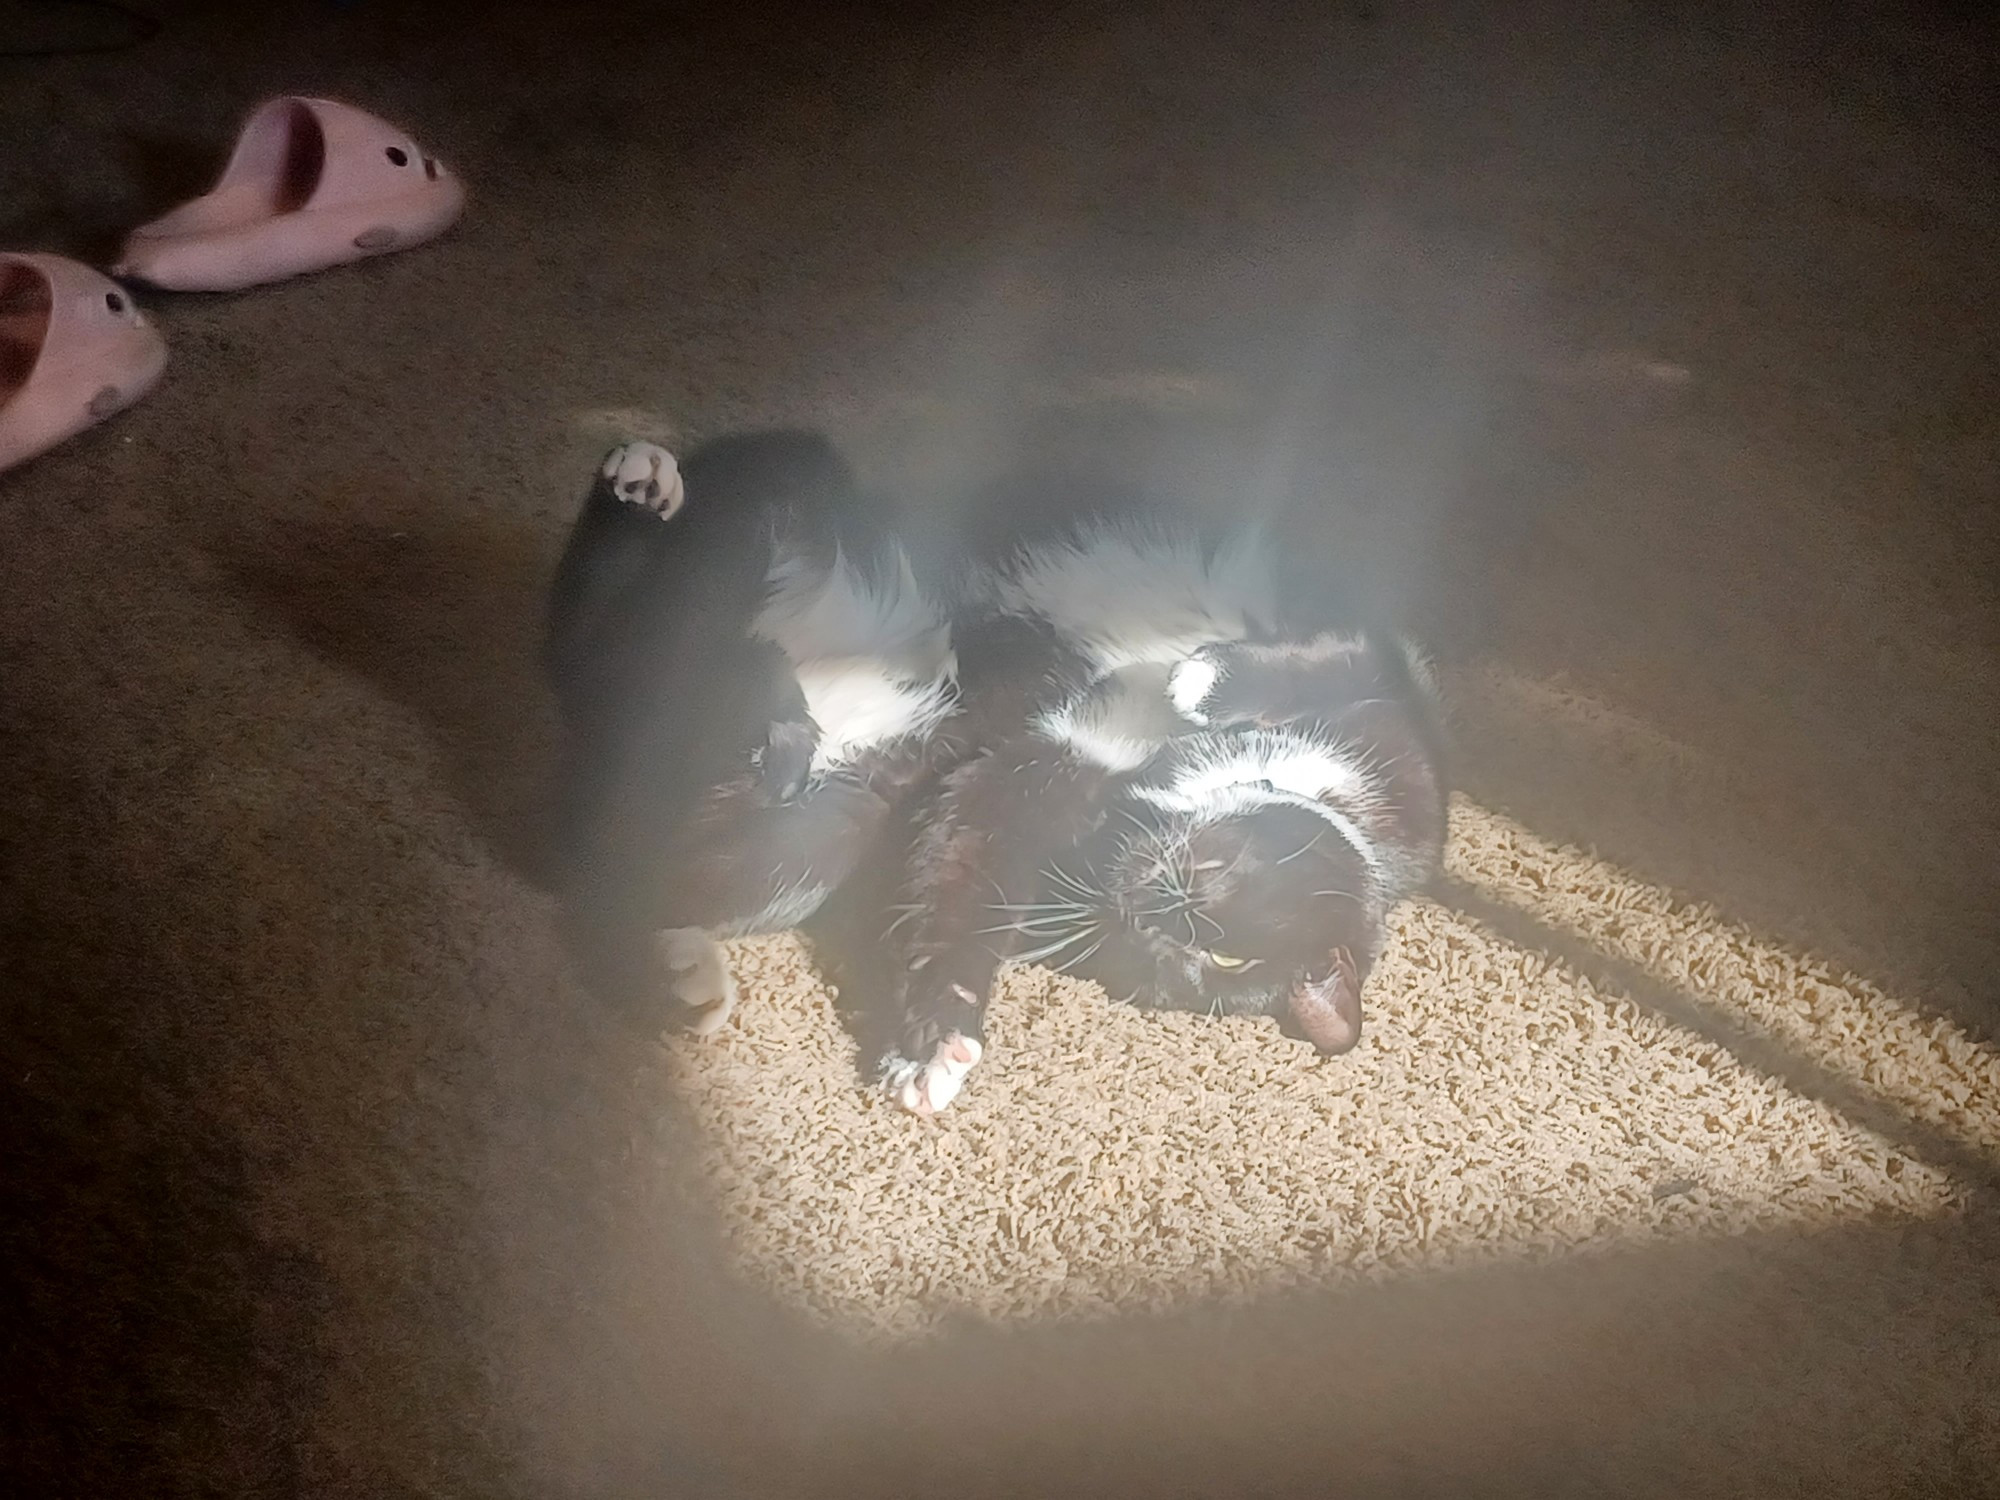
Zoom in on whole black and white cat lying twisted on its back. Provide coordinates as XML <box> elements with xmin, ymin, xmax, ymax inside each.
<box><xmin>548</xmin><ymin>432</ymin><xmax>1444</xmax><ymax>1112</ymax></box>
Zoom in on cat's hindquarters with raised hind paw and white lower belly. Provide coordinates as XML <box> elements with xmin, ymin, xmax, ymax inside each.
<box><xmin>544</xmin><ymin>432</ymin><xmax>954</xmax><ymax>1032</ymax></box>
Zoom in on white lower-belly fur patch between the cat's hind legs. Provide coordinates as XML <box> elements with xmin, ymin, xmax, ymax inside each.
<box><xmin>752</xmin><ymin>554</ymin><xmax>958</xmax><ymax>772</ymax></box>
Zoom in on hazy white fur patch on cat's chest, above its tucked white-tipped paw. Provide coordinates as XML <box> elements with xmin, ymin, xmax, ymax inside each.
<box><xmin>992</xmin><ymin>522</ymin><xmax>1276</xmax><ymax>672</ymax></box>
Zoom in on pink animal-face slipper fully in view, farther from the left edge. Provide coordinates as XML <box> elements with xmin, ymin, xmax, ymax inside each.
<box><xmin>114</xmin><ymin>98</ymin><xmax>466</xmax><ymax>292</ymax></box>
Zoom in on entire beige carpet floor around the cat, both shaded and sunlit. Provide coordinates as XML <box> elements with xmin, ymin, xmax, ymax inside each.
<box><xmin>0</xmin><ymin>0</ymin><xmax>2000</xmax><ymax>1500</ymax></box>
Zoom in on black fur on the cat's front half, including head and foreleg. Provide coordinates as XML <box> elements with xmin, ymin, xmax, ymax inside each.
<box><xmin>882</xmin><ymin>488</ymin><xmax>1444</xmax><ymax>1108</ymax></box>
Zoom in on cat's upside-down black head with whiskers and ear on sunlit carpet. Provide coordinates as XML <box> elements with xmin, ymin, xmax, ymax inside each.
<box><xmin>1072</xmin><ymin>802</ymin><xmax>1382</xmax><ymax>1052</ymax></box>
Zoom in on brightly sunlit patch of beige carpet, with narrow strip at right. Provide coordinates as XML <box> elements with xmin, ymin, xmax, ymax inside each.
<box><xmin>668</xmin><ymin>800</ymin><xmax>2000</xmax><ymax>1336</ymax></box>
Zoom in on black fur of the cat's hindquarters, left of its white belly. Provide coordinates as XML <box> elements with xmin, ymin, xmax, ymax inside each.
<box><xmin>544</xmin><ymin>432</ymin><xmax>948</xmax><ymax>1006</ymax></box>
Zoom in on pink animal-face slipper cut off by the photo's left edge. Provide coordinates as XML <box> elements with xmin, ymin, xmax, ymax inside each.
<box><xmin>0</xmin><ymin>254</ymin><xmax>166</xmax><ymax>468</ymax></box>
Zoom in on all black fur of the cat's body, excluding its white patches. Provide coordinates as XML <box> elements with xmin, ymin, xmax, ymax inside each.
<box><xmin>548</xmin><ymin>432</ymin><xmax>1444</xmax><ymax>1076</ymax></box>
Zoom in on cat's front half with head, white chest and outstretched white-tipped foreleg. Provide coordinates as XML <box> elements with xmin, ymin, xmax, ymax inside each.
<box><xmin>880</xmin><ymin>510</ymin><xmax>1446</xmax><ymax>1114</ymax></box>
